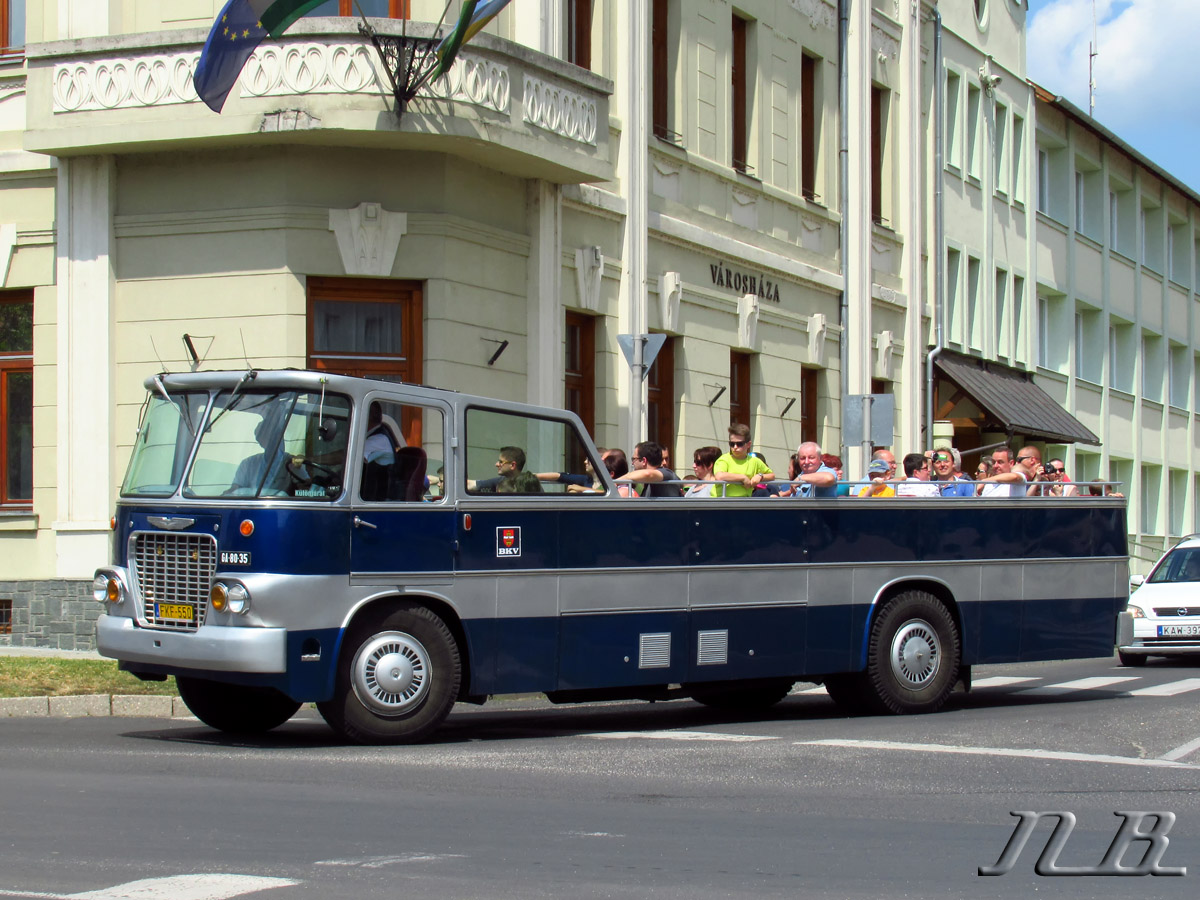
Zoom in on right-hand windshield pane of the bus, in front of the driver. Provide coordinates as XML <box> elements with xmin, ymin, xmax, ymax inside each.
<box><xmin>184</xmin><ymin>391</ymin><xmax>350</xmax><ymax>500</ymax></box>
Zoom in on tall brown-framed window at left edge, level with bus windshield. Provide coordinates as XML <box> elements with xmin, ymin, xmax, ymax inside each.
<box><xmin>0</xmin><ymin>290</ymin><xmax>34</xmax><ymax>506</ymax></box>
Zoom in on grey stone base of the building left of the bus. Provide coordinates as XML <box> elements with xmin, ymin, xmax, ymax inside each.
<box><xmin>0</xmin><ymin>578</ymin><xmax>101</xmax><ymax>650</ymax></box>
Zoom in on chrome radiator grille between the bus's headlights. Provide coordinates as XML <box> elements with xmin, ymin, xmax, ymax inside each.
<box><xmin>130</xmin><ymin>532</ymin><xmax>217</xmax><ymax>631</ymax></box>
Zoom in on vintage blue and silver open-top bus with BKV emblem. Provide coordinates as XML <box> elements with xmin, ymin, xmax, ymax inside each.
<box><xmin>95</xmin><ymin>370</ymin><xmax>1128</xmax><ymax>743</ymax></box>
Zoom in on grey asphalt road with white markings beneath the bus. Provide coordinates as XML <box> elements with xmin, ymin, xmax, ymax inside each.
<box><xmin>0</xmin><ymin>660</ymin><xmax>1200</xmax><ymax>900</ymax></box>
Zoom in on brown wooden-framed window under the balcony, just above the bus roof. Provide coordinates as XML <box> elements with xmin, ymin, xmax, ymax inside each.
<box><xmin>308</xmin><ymin>276</ymin><xmax>422</xmax><ymax>384</ymax></box>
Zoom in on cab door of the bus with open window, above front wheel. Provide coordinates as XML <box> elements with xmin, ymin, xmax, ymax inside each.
<box><xmin>347</xmin><ymin>391</ymin><xmax>455</xmax><ymax>578</ymax></box>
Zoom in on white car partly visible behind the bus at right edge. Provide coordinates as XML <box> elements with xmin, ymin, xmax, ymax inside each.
<box><xmin>1117</xmin><ymin>534</ymin><xmax>1200</xmax><ymax>666</ymax></box>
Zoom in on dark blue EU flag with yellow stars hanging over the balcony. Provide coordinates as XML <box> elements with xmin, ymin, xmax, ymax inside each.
<box><xmin>192</xmin><ymin>0</ymin><xmax>324</xmax><ymax>113</ymax></box>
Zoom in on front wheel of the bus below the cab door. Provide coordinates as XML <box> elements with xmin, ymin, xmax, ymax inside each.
<box><xmin>317</xmin><ymin>606</ymin><xmax>462</xmax><ymax>744</ymax></box>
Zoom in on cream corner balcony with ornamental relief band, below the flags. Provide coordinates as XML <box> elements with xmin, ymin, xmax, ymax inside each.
<box><xmin>24</xmin><ymin>18</ymin><xmax>614</xmax><ymax>184</ymax></box>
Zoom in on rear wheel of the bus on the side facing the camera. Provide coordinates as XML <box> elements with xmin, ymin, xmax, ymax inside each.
<box><xmin>865</xmin><ymin>590</ymin><xmax>962</xmax><ymax>713</ymax></box>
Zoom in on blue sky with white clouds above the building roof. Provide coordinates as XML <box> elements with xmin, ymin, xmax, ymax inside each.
<box><xmin>1026</xmin><ymin>0</ymin><xmax>1200</xmax><ymax>193</ymax></box>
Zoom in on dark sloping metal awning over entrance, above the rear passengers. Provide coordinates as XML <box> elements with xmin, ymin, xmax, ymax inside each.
<box><xmin>934</xmin><ymin>350</ymin><xmax>1100</xmax><ymax>444</ymax></box>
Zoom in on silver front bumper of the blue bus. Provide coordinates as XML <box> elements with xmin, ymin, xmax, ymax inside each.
<box><xmin>96</xmin><ymin>616</ymin><xmax>288</xmax><ymax>673</ymax></box>
